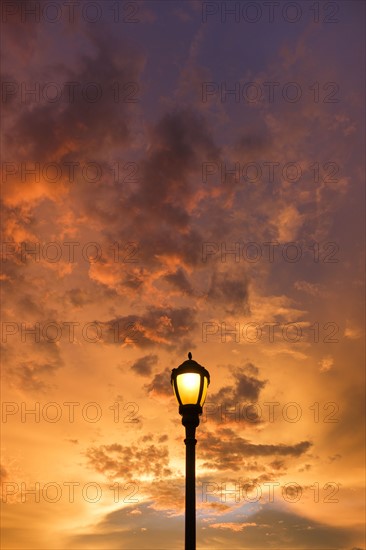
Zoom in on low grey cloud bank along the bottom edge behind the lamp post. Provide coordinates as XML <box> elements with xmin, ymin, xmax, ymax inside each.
<box><xmin>67</xmin><ymin>502</ymin><xmax>356</xmax><ymax>550</ymax></box>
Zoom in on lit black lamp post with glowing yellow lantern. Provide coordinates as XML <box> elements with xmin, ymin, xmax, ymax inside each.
<box><xmin>171</xmin><ymin>352</ymin><xmax>210</xmax><ymax>550</ymax></box>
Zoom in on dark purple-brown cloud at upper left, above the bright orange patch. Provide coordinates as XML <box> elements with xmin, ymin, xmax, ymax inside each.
<box><xmin>7</xmin><ymin>32</ymin><xmax>142</xmax><ymax>162</ymax></box>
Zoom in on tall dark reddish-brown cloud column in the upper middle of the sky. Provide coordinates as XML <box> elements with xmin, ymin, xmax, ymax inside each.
<box><xmin>98</xmin><ymin>108</ymin><xmax>219</xmax><ymax>266</ymax></box>
